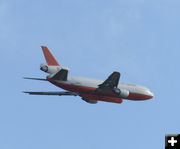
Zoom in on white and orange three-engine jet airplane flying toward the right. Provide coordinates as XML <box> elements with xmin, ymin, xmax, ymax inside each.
<box><xmin>24</xmin><ymin>46</ymin><xmax>154</xmax><ymax>104</ymax></box>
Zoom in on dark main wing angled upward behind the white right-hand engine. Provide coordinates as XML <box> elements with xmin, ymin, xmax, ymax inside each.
<box><xmin>96</xmin><ymin>72</ymin><xmax>120</xmax><ymax>92</ymax></box>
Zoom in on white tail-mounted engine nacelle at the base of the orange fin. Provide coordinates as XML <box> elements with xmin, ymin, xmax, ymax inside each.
<box><xmin>40</xmin><ymin>63</ymin><xmax>69</xmax><ymax>74</ymax></box>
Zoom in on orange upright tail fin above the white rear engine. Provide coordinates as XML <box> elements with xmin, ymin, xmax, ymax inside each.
<box><xmin>41</xmin><ymin>46</ymin><xmax>60</xmax><ymax>66</ymax></box>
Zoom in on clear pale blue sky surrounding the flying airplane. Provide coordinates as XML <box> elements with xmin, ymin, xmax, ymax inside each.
<box><xmin>0</xmin><ymin>0</ymin><xmax>180</xmax><ymax>149</ymax></box>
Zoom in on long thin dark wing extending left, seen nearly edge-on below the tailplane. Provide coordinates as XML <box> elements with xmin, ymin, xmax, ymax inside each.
<box><xmin>24</xmin><ymin>91</ymin><xmax>78</xmax><ymax>96</ymax></box>
